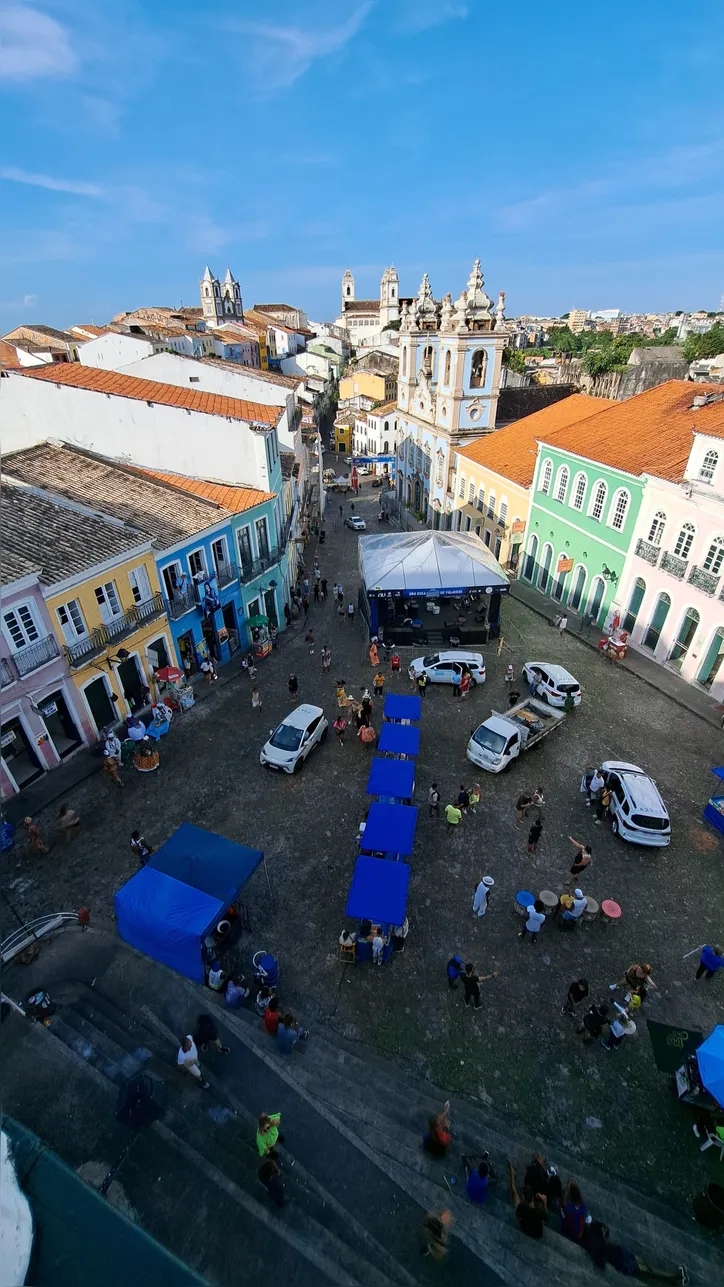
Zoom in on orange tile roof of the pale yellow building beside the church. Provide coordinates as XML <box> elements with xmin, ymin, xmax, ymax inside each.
<box><xmin>457</xmin><ymin>394</ymin><xmax>616</xmax><ymax>486</ymax></box>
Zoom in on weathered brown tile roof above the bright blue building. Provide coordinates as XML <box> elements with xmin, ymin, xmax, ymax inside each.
<box><xmin>3</xmin><ymin>443</ymin><xmax>229</xmax><ymax>550</ymax></box>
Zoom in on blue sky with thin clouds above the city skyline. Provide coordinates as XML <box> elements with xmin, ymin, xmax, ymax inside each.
<box><xmin>0</xmin><ymin>0</ymin><xmax>724</xmax><ymax>331</ymax></box>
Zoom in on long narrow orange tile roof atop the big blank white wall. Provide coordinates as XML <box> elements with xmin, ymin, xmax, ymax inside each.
<box><xmin>12</xmin><ymin>362</ymin><xmax>282</xmax><ymax>425</ymax></box>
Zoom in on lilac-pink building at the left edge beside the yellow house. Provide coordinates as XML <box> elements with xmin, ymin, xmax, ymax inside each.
<box><xmin>0</xmin><ymin>571</ymin><xmax>95</xmax><ymax>799</ymax></box>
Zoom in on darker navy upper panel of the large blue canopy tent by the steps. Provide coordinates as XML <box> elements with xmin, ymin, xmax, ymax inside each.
<box><xmin>148</xmin><ymin>822</ymin><xmax>264</xmax><ymax>907</ymax></box>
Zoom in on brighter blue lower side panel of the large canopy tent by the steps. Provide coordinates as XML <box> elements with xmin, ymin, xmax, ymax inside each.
<box><xmin>114</xmin><ymin>866</ymin><xmax>228</xmax><ymax>983</ymax></box>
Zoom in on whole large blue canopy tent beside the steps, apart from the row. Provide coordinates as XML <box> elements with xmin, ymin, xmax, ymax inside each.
<box><xmin>114</xmin><ymin>822</ymin><xmax>269</xmax><ymax>983</ymax></box>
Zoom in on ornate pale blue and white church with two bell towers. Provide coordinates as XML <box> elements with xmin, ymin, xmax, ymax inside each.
<box><xmin>397</xmin><ymin>259</ymin><xmax>508</xmax><ymax>529</ymax></box>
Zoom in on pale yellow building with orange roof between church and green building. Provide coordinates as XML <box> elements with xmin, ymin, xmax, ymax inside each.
<box><xmin>450</xmin><ymin>394</ymin><xmax>611</xmax><ymax>571</ymax></box>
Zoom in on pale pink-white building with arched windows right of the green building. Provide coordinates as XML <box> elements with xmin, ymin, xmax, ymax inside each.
<box><xmin>613</xmin><ymin>431</ymin><xmax>724</xmax><ymax>701</ymax></box>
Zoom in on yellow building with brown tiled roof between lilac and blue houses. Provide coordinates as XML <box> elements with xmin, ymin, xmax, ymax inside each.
<box><xmin>3</xmin><ymin>480</ymin><xmax>175</xmax><ymax>734</ymax></box>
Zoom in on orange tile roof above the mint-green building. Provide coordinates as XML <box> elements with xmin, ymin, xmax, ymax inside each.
<box><xmin>540</xmin><ymin>380</ymin><xmax>724</xmax><ymax>483</ymax></box>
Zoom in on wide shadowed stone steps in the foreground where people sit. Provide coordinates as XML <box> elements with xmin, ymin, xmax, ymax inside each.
<box><xmin>42</xmin><ymin>983</ymin><xmax>721</xmax><ymax>1287</ymax></box>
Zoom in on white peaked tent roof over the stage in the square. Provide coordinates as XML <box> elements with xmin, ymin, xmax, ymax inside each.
<box><xmin>360</xmin><ymin>532</ymin><xmax>508</xmax><ymax>597</ymax></box>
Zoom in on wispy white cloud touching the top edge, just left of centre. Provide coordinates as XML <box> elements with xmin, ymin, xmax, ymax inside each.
<box><xmin>228</xmin><ymin>0</ymin><xmax>372</xmax><ymax>94</ymax></box>
